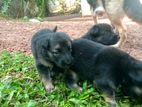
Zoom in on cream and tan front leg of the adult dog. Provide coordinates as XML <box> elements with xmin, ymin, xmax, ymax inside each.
<box><xmin>104</xmin><ymin>0</ymin><xmax>127</xmax><ymax>47</ymax></box>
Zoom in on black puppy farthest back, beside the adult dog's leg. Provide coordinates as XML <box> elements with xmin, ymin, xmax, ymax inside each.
<box><xmin>82</xmin><ymin>23</ymin><xmax>119</xmax><ymax>45</ymax></box>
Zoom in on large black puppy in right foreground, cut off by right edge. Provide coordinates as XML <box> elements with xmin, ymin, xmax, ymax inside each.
<box><xmin>70</xmin><ymin>38</ymin><xmax>142</xmax><ymax>106</ymax></box>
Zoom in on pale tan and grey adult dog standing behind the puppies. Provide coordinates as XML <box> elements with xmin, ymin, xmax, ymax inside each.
<box><xmin>88</xmin><ymin>0</ymin><xmax>142</xmax><ymax>47</ymax></box>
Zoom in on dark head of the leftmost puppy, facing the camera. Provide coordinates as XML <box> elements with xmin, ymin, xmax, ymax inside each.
<box><xmin>44</xmin><ymin>32</ymin><xmax>73</xmax><ymax>68</ymax></box>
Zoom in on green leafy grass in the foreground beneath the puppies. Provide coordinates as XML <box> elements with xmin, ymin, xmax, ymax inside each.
<box><xmin>0</xmin><ymin>51</ymin><xmax>142</xmax><ymax>107</ymax></box>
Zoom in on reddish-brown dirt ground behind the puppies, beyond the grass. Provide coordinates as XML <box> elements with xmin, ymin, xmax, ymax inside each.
<box><xmin>0</xmin><ymin>17</ymin><xmax>142</xmax><ymax>59</ymax></box>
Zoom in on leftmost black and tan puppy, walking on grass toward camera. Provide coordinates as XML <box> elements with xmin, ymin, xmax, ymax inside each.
<box><xmin>31</xmin><ymin>27</ymin><xmax>72</xmax><ymax>91</ymax></box>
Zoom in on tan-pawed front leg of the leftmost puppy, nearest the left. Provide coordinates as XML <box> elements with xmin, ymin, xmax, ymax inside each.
<box><xmin>36</xmin><ymin>64</ymin><xmax>54</xmax><ymax>92</ymax></box>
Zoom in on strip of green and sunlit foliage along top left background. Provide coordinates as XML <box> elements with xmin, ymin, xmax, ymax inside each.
<box><xmin>0</xmin><ymin>0</ymin><xmax>81</xmax><ymax>18</ymax></box>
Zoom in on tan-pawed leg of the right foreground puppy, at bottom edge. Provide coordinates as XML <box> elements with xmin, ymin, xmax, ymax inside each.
<box><xmin>93</xmin><ymin>78</ymin><xmax>116</xmax><ymax>107</ymax></box>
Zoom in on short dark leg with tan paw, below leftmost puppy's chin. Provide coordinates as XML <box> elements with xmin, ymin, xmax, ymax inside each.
<box><xmin>65</xmin><ymin>70</ymin><xmax>82</xmax><ymax>91</ymax></box>
